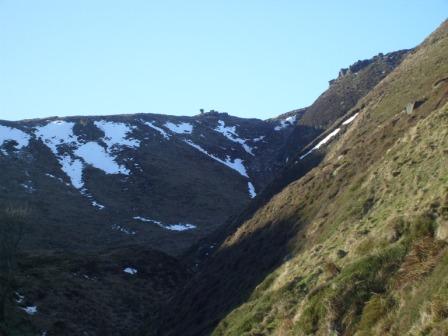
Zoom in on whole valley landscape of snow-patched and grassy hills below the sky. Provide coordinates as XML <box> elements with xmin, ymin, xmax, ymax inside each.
<box><xmin>0</xmin><ymin>22</ymin><xmax>448</xmax><ymax>336</ymax></box>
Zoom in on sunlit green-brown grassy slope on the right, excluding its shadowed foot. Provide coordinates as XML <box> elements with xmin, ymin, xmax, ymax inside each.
<box><xmin>214</xmin><ymin>23</ymin><xmax>448</xmax><ymax>335</ymax></box>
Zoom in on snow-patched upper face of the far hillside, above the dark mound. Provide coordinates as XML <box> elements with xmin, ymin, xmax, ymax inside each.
<box><xmin>0</xmin><ymin>112</ymin><xmax>304</xmax><ymax>253</ymax></box>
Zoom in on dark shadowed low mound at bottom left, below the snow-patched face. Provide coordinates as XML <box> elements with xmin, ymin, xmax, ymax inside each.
<box><xmin>7</xmin><ymin>246</ymin><xmax>190</xmax><ymax>336</ymax></box>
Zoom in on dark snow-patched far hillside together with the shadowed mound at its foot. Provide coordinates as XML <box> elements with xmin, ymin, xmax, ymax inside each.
<box><xmin>0</xmin><ymin>112</ymin><xmax>302</xmax><ymax>335</ymax></box>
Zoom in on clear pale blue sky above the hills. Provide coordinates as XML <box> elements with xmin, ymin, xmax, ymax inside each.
<box><xmin>0</xmin><ymin>0</ymin><xmax>448</xmax><ymax>120</ymax></box>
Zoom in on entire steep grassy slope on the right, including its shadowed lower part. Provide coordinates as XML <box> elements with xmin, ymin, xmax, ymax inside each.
<box><xmin>160</xmin><ymin>22</ymin><xmax>448</xmax><ymax>335</ymax></box>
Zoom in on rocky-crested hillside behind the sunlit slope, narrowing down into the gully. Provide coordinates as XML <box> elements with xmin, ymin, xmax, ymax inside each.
<box><xmin>181</xmin><ymin>50</ymin><xmax>410</xmax><ymax>265</ymax></box>
